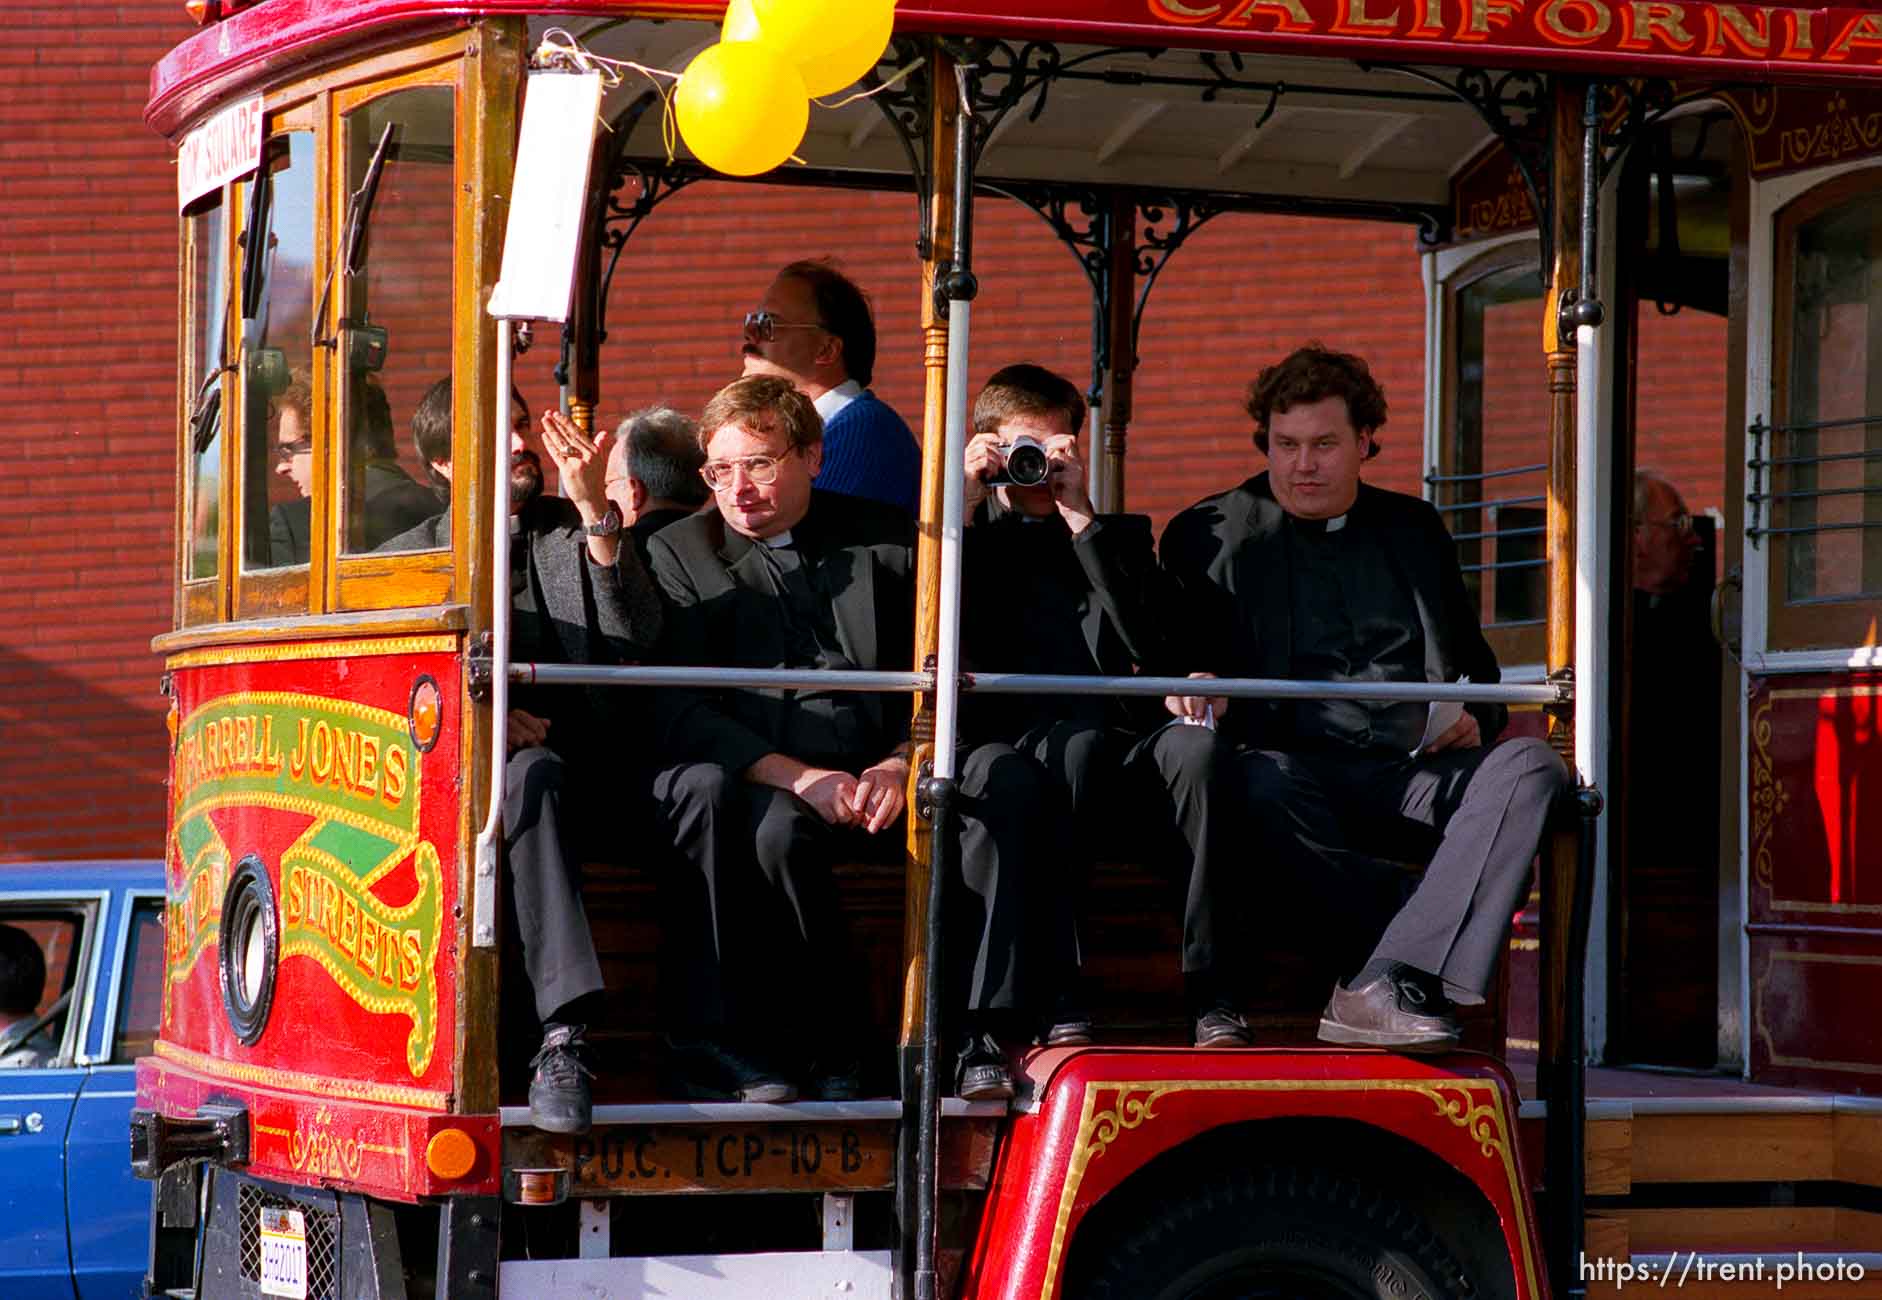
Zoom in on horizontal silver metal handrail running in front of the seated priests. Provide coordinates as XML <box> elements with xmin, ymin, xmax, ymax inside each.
<box><xmin>510</xmin><ymin>664</ymin><xmax>1573</xmax><ymax>704</ymax></box>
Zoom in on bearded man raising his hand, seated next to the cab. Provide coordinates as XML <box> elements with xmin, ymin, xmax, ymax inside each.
<box><xmin>384</xmin><ymin>381</ymin><xmax>661</xmax><ymax>1133</ymax></box>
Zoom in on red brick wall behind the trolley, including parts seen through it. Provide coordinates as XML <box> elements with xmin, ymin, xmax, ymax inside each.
<box><xmin>0</xmin><ymin>12</ymin><xmax>1722</xmax><ymax>860</ymax></box>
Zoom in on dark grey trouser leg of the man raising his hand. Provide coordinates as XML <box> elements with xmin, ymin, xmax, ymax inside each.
<box><xmin>502</xmin><ymin>747</ymin><xmax>602</xmax><ymax>1020</ymax></box>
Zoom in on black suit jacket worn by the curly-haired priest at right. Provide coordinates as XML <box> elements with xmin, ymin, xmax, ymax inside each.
<box><xmin>1159</xmin><ymin>474</ymin><xmax>1509</xmax><ymax>749</ymax></box>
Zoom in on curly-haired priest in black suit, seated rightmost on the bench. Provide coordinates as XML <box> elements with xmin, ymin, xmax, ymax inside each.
<box><xmin>1161</xmin><ymin>344</ymin><xmax>1570</xmax><ymax>1050</ymax></box>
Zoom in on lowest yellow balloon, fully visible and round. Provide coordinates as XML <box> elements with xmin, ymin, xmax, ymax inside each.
<box><xmin>674</xmin><ymin>41</ymin><xmax>811</xmax><ymax>177</ymax></box>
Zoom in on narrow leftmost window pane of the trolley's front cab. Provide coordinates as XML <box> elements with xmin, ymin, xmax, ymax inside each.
<box><xmin>184</xmin><ymin>194</ymin><xmax>228</xmax><ymax>579</ymax></box>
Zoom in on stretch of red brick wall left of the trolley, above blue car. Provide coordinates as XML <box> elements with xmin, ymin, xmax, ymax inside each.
<box><xmin>0</xmin><ymin>0</ymin><xmax>194</xmax><ymax>858</ymax></box>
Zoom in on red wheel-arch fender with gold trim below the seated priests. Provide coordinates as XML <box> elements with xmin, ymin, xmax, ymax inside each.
<box><xmin>962</xmin><ymin>1050</ymin><xmax>1547</xmax><ymax>1300</ymax></box>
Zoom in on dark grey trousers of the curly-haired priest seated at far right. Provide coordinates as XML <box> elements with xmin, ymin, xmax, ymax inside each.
<box><xmin>1244</xmin><ymin>739</ymin><xmax>1570</xmax><ymax>1003</ymax></box>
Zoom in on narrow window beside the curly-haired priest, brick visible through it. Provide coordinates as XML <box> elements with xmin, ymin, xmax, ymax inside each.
<box><xmin>1438</xmin><ymin>262</ymin><xmax>1549</xmax><ymax>628</ymax></box>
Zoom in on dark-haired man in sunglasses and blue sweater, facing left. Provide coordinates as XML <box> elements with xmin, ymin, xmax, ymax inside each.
<box><xmin>740</xmin><ymin>262</ymin><xmax>922</xmax><ymax>515</ymax></box>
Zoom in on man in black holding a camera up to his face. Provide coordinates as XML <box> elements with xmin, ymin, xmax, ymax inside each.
<box><xmin>964</xmin><ymin>365</ymin><xmax>1250</xmax><ymax>1048</ymax></box>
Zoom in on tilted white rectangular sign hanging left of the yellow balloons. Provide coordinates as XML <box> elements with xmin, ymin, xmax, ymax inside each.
<box><xmin>489</xmin><ymin>71</ymin><xmax>600</xmax><ymax>320</ymax></box>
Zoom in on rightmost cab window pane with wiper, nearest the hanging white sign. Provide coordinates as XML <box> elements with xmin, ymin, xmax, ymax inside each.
<box><xmin>341</xmin><ymin>87</ymin><xmax>457</xmax><ymax>555</ymax></box>
